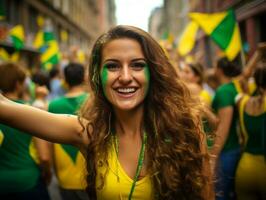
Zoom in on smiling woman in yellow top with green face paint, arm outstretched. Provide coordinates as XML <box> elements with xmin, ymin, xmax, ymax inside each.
<box><xmin>0</xmin><ymin>26</ymin><xmax>213</xmax><ymax>200</ymax></box>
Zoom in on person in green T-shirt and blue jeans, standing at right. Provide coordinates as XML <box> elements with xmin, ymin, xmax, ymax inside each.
<box><xmin>210</xmin><ymin>58</ymin><xmax>242</xmax><ymax>200</ymax></box>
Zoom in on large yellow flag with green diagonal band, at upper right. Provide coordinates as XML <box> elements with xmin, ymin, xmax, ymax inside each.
<box><xmin>189</xmin><ymin>9</ymin><xmax>241</xmax><ymax>60</ymax></box>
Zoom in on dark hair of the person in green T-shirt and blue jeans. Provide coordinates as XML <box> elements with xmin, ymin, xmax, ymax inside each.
<box><xmin>217</xmin><ymin>57</ymin><xmax>242</xmax><ymax>78</ymax></box>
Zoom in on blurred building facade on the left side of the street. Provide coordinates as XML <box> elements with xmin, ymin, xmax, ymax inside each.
<box><xmin>0</xmin><ymin>0</ymin><xmax>115</xmax><ymax>68</ymax></box>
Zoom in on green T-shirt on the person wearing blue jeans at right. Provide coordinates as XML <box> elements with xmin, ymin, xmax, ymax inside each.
<box><xmin>212</xmin><ymin>82</ymin><xmax>239</xmax><ymax>152</ymax></box>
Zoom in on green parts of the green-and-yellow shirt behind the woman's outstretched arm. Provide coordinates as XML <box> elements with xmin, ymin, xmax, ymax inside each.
<box><xmin>48</xmin><ymin>93</ymin><xmax>88</xmax><ymax>163</ymax></box>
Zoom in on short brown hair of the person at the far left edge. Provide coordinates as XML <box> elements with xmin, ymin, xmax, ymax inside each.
<box><xmin>0</xmin><ymin>63</ymin><xmax>26</xmax><ymax>93</ymax></box>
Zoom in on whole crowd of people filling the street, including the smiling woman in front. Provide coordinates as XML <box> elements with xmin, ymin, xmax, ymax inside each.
<box><xmin>0</xmin><ymin>25</ymin><xmax>266</xmax><ymax>200</ymax></box>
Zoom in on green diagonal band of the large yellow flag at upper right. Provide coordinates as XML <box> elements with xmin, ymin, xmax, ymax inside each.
<box><xmin>210</xmin><ymin>10</ymin><xmax>236</xmax><ymax>50</ymax></box>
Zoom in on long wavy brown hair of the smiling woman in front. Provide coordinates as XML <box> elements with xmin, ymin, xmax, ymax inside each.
<box><xmin>80</xmin><ymin>26</ymin><xmax>210</xmax><ymax>200</ymax></box>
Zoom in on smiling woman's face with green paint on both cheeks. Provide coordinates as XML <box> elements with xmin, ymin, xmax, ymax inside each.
<box><xmin>101</xmin><ymin>38</ymin><xmax>150</xmax><ymax>110</ymax></box>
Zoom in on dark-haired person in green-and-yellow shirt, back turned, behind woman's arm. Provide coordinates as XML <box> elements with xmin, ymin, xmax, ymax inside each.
<box><xmin>48</xmin><ymin>63</ymin><xmax>88</xmax><ymax>200</ymax></box>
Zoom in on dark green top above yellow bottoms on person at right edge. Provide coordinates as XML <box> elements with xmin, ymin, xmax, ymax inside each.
<box><xmin>244</xmin><ymin>112</ymin><xmax>266</xmax><ymax>155</ymax></box>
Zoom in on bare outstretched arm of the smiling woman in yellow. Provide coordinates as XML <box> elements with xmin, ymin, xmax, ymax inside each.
<box><xmin>0</xmin><ymin>94</ymin><xmax>88</xmax><ymax>148</ymax></box>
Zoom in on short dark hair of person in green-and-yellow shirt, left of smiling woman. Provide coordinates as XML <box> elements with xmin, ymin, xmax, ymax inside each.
<box><xmin>64</xmin><ymin>63</ymin><xmax>85</xmax><ymax>87</ymax></box>
